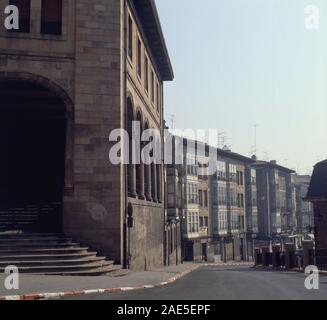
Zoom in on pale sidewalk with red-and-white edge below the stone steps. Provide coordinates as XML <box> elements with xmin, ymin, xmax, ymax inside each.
<box><xmin>0</xmin><ymin>262</ymin><xmax>254</xmax><ymax>300</ymax></box>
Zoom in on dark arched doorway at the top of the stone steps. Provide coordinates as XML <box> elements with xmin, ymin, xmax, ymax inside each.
<box><xmin>0</xmin><ymin>81</ymin><xmax>66</xmax><ymax>232</ymax></box>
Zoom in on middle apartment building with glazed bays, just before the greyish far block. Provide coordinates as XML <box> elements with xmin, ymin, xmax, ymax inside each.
<box><xmin>211</xmin><ymin>149</ymin><xmax>257</xmax><ymax>261</ymax></box>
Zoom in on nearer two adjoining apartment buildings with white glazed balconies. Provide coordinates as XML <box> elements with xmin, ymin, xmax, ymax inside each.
<box><xmin>167</xmin><ymin>137</ymin><xmax>258</xmax><ymax>261</ymax></box>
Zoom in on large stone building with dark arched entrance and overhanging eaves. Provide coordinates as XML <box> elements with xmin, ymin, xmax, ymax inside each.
<box><xmin>0</xmin><ymin>0</ymin><xmax>173</xmax><ymax>270</ymax></box>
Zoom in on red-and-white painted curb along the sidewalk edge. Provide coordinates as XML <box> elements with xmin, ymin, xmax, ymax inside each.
<box><xmin>0</xmin><ymin>265</ymin><xmax>201</xmax><ymax>301</ymax></box>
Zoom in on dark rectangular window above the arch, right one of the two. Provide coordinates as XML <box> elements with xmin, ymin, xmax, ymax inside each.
<box><xmin>41</xmin><ymin>0</ymin><xmax>62</xmax><ymax>34</ymax></box>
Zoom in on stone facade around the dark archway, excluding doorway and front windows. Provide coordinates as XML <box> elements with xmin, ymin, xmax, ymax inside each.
<box><xmin>0</xmin><ymin>0</ymin><xmax>173</xmax><ymax>270</ymax></box>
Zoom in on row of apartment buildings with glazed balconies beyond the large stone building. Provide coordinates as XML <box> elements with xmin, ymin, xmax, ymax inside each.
<box><xmin>167</xmin><ymin>137</ymin><xmax>313</xmax><ymax>262</ymax></box>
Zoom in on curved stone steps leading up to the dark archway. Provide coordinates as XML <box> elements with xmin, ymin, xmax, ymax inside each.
<box><xmin>0</xmin><ymin>233</ymin><xmax>126</xmax><ymax>276</ymax></box>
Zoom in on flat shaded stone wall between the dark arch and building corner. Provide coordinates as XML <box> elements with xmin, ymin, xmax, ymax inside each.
<box><xmin>64</xmin><ymin>0</ymin><xmax>124</xmax><ymax>262</ymax></box>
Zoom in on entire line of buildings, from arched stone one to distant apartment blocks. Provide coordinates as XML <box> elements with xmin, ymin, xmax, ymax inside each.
<box><xmin>0</xmin><ymin>0</ymin><xmax>312</xmax><ymax>270</ymax></box>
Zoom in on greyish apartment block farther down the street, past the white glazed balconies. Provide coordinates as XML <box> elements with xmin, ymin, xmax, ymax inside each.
<box><xmin>253</xmin><ymin>161</ymin><xmax>296</xmax><ymax>239</ymax></box>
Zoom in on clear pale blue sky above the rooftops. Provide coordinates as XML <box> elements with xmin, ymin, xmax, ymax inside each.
<box><xmin>156</xmin><ymin>0</ymin><xmax>327</xmax><ymax>173</ymax></box>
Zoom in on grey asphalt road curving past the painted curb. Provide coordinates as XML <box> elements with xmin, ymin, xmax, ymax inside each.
<box><xmin>63</xmin><ymin>267</ymin><xmax>327</xmax><ymax>301</ymax></box>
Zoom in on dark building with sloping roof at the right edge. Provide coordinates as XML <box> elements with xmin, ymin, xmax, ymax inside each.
<box><xmin>306</xmin><ymin>160</ymin><xmax>327</xmax><ymax>270</ymax></box>
